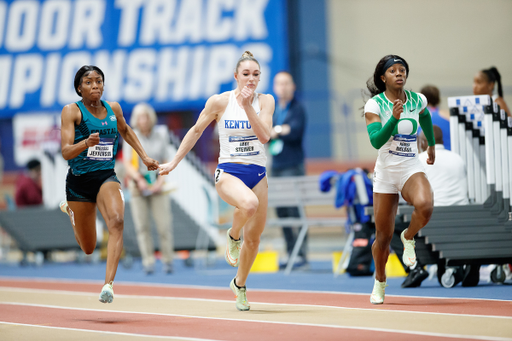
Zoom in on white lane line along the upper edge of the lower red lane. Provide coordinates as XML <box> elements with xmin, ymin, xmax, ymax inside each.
<box><xmin>0</xmin><ymin>302</ymin><xmax>512</xmax><ymax>341</ymax></box>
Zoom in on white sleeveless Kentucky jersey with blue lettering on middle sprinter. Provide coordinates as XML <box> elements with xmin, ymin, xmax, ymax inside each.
<box><xmin>219</xmin><ymin>91</ymin><xmax>267</xmax><ymax>167</ymax></box>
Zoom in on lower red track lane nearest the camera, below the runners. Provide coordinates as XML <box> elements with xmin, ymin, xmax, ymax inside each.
<box><xmin>0</xmin><ymin>303</ymin><xmax>472</xmax><ymax>341</ymax></box>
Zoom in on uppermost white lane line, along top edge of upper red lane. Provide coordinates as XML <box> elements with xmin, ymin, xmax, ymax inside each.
<box><xmin>0</xmin><ymin>276</ymin><xmax>512</xmax><ymax>302</ymax></box>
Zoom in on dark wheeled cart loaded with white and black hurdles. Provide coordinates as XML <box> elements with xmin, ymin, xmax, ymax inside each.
<box><xmin>399</xmin><ymin>96</ymin><xmax>512</xmax><ymax>287</ymax></box>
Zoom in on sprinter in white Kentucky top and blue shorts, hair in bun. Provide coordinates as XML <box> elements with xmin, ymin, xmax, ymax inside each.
<box><xmin>159</xmin><ymin>51</ymin><xmax>275</xmax><ymax>311</ymax></box>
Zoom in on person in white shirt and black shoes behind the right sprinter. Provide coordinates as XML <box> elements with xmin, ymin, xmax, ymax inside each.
<box><xmin>392</xmin><ymin>125</ymin><xmax>469</xmax><ymax>288</ymax></box>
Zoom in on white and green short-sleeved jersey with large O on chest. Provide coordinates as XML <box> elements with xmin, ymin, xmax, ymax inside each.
<box><xmin>364</xmin><ymin>90</ymin><xmax>428</xmax><ymax>166</ymax></box>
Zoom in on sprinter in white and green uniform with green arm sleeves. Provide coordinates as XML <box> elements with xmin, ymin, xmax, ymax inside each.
<box><xmin>364</xmin><ymin>55</ymin><xmax>435</xmax><ymax>304</ymax></box>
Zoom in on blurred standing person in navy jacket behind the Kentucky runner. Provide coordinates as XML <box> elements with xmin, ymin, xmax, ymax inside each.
<box><xmin>269</xmin><ymin>71</ymin><xmax>308</xmax><ymax>268</ymax></box>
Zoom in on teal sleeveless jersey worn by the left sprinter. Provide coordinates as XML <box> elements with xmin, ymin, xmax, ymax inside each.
<box><xmin>68</xmin><ymin>100</ymin><xmax>118</xmax><ymax>175</ymax></box>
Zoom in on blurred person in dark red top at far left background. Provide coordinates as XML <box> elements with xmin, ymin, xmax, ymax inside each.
<box><xmin>15</xmin><ymin>159</ymin><xmax>43</xmax><ymax>207</ymax></box>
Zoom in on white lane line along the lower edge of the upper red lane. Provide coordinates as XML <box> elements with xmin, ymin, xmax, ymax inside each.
<box><xmin>0</xmin><ymin>287</ymin><xmax>512</xmax><ymax>320</ymax></box>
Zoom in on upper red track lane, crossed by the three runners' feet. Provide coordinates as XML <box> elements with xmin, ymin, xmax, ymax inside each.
<box><xmin>0</xmin><ymin>279</ymin><xmax>512</xmax><ymax>317</ymax></box>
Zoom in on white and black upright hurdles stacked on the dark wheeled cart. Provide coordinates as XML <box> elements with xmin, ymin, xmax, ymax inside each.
<box><xmin>448</xmin><ymin>95</ymin><xmax>512</xmax><ymax>224</ymax></box>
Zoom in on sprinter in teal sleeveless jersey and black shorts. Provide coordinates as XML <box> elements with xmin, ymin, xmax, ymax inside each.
<box><xmin>60</xmin><ymin>65</ymin><xmax>158</xmax><ymax>303</ymax></box>
